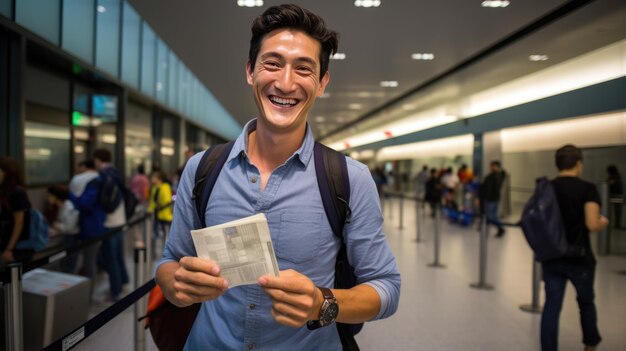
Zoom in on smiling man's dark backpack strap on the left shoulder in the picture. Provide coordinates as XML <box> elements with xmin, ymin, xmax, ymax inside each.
<box><xmin>192</xmin><ymin>141</ymin><xmax>235</xmax><ymax>228</ymax></box>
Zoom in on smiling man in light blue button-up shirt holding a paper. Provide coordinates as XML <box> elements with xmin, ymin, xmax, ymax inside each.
<box><xmin>156</xmin><ymin>5</ymin><xmax>400</xmax><ymax>350</ymax></box>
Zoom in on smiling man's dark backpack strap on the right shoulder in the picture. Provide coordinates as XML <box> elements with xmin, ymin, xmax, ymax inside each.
<box><xmin>313</xmin><ymin>142</ymin><xmax>352</xmax><ymax>242</ymax></box>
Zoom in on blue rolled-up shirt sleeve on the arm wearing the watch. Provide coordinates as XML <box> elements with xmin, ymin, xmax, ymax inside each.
<box><xmin>344</xmin><ymin>164</ymin><xmax>401</xmax><ymax>319</ymax></box>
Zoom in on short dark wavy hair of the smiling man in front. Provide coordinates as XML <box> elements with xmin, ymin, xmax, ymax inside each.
<box><xmin>248</xmin><ymin>4</ymin><xmax>339</xmax><ymax>80</ymax></box>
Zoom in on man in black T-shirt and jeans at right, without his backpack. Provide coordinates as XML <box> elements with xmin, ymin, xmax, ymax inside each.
<box><xmin>541</xmin><ymin>145</ymin><xmax>608</xmax><ymax>351</ymax></box>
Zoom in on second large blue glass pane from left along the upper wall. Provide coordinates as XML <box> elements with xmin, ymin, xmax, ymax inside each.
<box><xmin>61</xmin><ymin>0</ymin><xmax>95</xmax><ymax>64</ymax></box>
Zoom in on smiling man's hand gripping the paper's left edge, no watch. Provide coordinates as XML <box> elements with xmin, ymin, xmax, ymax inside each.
<box><xmin>167</xmin><ymin>256</ymin><xmax>228</xmax><ymax>307</ymax></box>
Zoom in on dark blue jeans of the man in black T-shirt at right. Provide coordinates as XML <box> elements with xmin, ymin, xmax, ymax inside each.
<box><xmin>541</xmin><ymin>261</ymin><xmax>602</xmax><ymax>351</ymax></box>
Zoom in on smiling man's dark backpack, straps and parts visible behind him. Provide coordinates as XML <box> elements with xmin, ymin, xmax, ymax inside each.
<box><xmin>146</xmin><ymin>141</ymin><xmax>363</xmax><ymax>351</ymax></box>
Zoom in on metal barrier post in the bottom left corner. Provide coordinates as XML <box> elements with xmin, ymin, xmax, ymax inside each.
<box><xmin>4</xmin><ymin>263</ymin><xmax>24</xmax><ymax>351</ymax></box>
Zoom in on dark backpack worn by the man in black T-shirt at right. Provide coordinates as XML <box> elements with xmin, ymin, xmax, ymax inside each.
<box><xmin>520</xmin><ymin>177</ymin><xmax>585</xmax><ymax>262</ymax></box>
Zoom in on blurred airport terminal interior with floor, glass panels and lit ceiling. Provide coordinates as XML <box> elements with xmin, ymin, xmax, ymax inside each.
<box><xmin>0</xmin><ymin>0</ymin><xmax>626</xmax><ymax>351</ymax></box>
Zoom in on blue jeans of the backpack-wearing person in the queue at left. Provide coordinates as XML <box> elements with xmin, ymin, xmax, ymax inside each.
<box><xmin>101</xmin><ymin>233</ymin><xmax>128</xmax><ymax>299</ymax></box>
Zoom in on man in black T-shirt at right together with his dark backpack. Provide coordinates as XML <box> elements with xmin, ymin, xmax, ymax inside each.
<box><xmin>521</xmin><ymin>145</ymin><xmax>608</xmax><ymax>351</ymax></box>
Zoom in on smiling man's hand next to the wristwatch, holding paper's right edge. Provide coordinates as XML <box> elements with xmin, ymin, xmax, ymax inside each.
<box><xmin>259</xmin><ymin>269</ymin><xmax>324</xmax><ymax>328</ymax></box>
